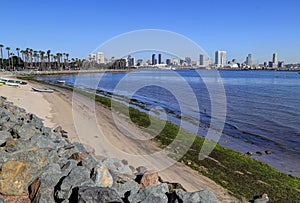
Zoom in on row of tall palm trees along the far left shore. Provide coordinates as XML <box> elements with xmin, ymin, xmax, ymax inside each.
<box><xmin>0</xmin><ymin>44</ymin><xmax>82</xmax><ymax>71</ymax></box>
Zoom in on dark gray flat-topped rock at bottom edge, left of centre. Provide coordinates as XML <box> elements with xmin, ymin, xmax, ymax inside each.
<box><xmin>70</xmin><ymin>187</ymin><xmax>123</xmax><ymax>203</ymax></box>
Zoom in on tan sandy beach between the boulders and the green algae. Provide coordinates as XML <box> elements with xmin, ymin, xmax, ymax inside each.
<box><xmin>0</xmin><ymin>74</ymin><xmax>239</xmax><ymax>202</ymax></box>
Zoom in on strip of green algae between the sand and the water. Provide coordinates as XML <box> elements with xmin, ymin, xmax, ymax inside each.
<box><xmin>23</xmin><ymin>77</ymin><xmax>300</xmax><ymax>203</ymax></box>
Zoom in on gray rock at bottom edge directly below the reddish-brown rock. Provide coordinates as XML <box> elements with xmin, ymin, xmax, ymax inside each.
<box><xmin>128</xmin><ymin>183</ymin><xmax>169</xmax><ymax>203</ymax></box>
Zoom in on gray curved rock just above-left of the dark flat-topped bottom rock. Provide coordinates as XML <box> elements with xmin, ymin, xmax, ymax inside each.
<box><xmin>55</xmin><ymin>166</ymin><xmax>95</xmax><ymax>200</ymax></box>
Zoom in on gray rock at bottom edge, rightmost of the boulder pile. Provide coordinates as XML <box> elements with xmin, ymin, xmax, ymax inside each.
<box><xmin>174</xmin><ymin>190</ymin><xmax>219</xmax><ymax>203</ymax></box>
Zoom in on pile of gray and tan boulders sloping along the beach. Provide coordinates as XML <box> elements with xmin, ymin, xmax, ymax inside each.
<box><xmin>0</xmin><ymin>97</ymin><xmax>218</xmax><ymax>203</ymax></box>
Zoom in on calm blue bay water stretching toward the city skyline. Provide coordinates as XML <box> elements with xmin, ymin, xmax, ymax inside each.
<box><xmin>39</xmin><ymin>70</ymin><xmax>300</xmax><ymax>177</ymax></box>
